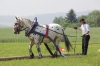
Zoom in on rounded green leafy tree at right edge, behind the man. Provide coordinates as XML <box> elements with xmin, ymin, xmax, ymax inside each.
<box><xmin>86</xmin><ymin>10</ymin><xmax>100</xmax><ymax>27</ymax></box>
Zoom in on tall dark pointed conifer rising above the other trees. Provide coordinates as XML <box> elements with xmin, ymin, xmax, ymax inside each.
<box><xmin>65</xmin><ymin>9</ymin><xmax>77</xmax><ymax>23</ymax></box>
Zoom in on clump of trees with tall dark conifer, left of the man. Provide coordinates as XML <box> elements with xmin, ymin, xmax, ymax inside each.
<box><xmin>53</xmin><ymin>9</ymin><xmax>79</xmax><ymax>28</ymax></box>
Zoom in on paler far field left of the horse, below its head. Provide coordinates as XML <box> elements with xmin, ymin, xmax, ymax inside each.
<box><xmin>0</xmin><ymin>28</ymin><xmax>29</xmax><ymax>43</ymax></box>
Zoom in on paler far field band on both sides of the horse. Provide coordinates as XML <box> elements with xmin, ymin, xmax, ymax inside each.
<box><xmin>0</xmin><ymin>27</ymin><xmax>100</xmax><ymax>44</ymax></box>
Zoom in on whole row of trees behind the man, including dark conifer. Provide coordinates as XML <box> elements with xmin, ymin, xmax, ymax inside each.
<box><xmin>53</xmin><ymin>9</ymin><xmax>100</xmax><ymax>28</ymax></box>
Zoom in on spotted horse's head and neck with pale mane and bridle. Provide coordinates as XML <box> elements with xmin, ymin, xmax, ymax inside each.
<box><xmin>14</xmin><ymin>17</ymin><xmax>35</xmax><ymax>34</ymax></box>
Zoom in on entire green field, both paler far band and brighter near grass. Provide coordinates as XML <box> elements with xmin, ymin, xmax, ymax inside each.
<box><xmin>0</xmin><ymin>28</ymin><xmax>100</xmax><ymax>66</ymax></box>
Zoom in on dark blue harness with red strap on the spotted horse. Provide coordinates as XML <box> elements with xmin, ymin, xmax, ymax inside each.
<box><xmin>25</xmin><ymin>22</ymin><xmax>61</xmax><ymax>56</ymax></box>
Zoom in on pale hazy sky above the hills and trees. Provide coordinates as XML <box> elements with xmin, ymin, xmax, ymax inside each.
<box><xmin>0</xmin><ymin>0</ymin><xmax>100</xmax><ymax>16</ymax></box>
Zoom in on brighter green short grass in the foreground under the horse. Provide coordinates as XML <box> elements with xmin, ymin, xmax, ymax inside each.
<box><xmin>0</xmin><ymin>43</ymin><xmax>100</xmax><ymax>66</ymax></box>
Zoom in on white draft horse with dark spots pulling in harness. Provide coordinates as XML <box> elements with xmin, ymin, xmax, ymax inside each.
<box><xmin>14</xmin><ymin>17</ymin><xmax>71</xmax><ymax>58</ymax></box>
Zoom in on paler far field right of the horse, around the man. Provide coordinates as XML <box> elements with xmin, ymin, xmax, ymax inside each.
<box><xmin>66</xmin><ymin>27</ymin><xmax>100</xmax><ymax>44</ymax></box>
